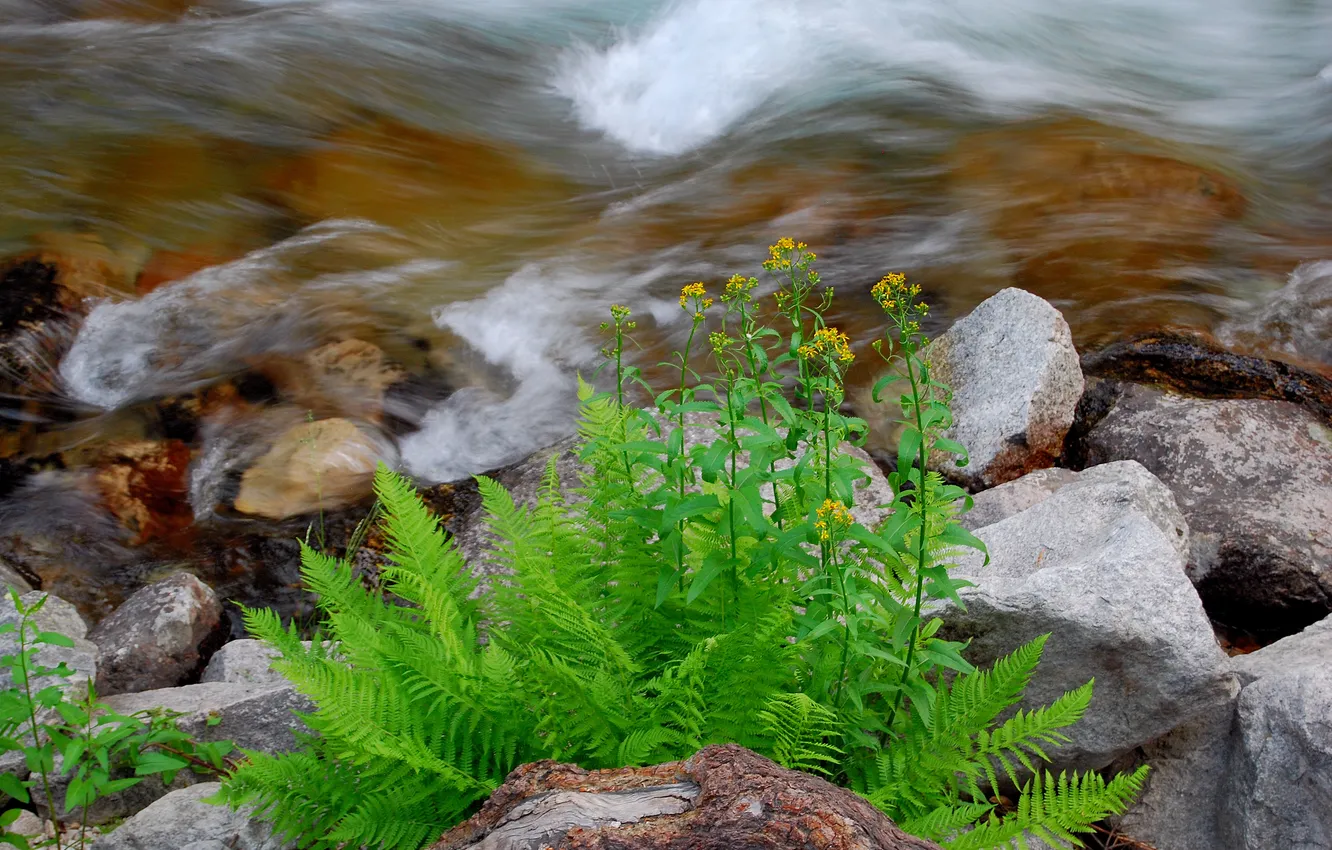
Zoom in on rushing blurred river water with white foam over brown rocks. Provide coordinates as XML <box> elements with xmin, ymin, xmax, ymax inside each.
<box><xmin>0</xmin><ymin>0</ymin><xmax>1332</xmax><ymax>615</ymax></box>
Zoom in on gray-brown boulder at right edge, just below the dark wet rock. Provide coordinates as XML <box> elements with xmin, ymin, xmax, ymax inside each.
<box><xmin>1084</xmin><ymin>385</ymin><xmax>1332</xmax><ymax>632</ymax></box>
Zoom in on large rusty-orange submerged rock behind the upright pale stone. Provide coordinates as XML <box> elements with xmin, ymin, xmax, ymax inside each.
<box><xmin>947</xmin><ymin>120</ymin><xmax>1245</xmax><ymax>309</ymax></box>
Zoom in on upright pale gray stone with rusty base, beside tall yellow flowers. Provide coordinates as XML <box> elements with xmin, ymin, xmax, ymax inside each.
<box><xmin>928</xmin><ymin>289</ymin><xmax>1083</xmax><ymax>490</ymax></box>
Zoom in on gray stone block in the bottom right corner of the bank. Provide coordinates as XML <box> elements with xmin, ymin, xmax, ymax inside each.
<box><xmin>1220</xmin><ymin>621</ymin><xmax>1332</xmax><ymax>850</ymax></box>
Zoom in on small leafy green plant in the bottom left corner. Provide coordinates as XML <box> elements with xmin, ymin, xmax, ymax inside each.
<box><xmin>0</xmin><ymin>590</ymin><xmax>236</xmax><ymax>850</ymax></box>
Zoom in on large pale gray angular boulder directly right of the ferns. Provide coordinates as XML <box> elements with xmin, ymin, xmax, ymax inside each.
<box><xmin>939</xmin><ymin>462</ymin><xmax>1233</xmax><ymax>769</ymax></box>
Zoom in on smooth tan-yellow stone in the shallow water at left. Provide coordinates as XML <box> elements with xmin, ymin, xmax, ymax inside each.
<box><xmin>234</xmin><ymin>418</ymin><xmax>392</xmax><ymax>520</ymax></box>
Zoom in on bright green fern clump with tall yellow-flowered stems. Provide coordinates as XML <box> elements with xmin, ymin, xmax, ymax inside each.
<box><xmin>218</xmin><ymin>240</ymin><xmax>1146</xmax><ymax>850</ymax></box>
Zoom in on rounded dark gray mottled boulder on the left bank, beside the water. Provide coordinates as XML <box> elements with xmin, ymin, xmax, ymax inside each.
<box><xmin>88</xmin><ymin>573</ymin><xmax>222</xmax><ymax>695</ymax></box>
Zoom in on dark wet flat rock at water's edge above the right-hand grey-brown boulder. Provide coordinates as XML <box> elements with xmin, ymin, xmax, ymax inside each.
<box><xmin>1082</xmin><ymin>332</ymin><xmax>1332</xmax><ymax>422</ymax></box>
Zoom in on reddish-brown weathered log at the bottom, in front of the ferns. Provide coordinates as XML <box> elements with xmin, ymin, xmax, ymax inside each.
<box><xmin>430</xmin><ymin>745</ymin><xmax>939</xmax><ymax>850</ymax></box>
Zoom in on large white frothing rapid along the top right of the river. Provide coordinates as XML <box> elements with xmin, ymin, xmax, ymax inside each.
<box><xmin>554</xmin><ymin>0</ymin><xmax>1332</xmax><ymax>155</ymax></box>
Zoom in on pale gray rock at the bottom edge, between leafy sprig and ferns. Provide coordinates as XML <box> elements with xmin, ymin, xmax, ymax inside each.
<box><xmin>92</xmin><ymin>782</ymin><xmax>293</xmax><ymax>850</ymax></box>
